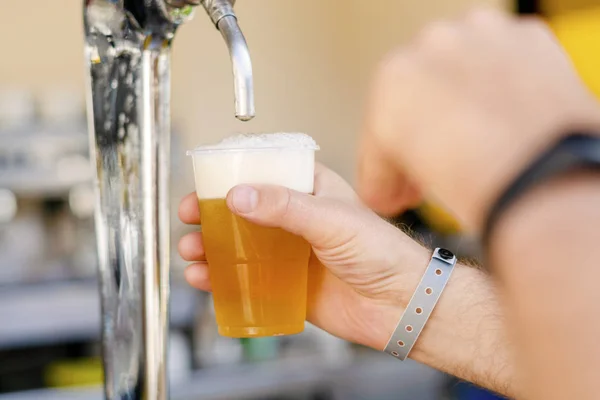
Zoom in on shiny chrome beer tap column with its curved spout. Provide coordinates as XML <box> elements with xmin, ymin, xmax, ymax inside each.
<box><xmin>83</xmin><ymin>0</ymin><xmax>254</xmax><ymax>400</ymax></box>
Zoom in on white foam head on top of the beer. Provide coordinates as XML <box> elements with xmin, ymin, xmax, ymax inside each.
<box><xmin>188</xmin><ymin>133</ymin><xmax>319</xmax><ymax>199</ymax></box>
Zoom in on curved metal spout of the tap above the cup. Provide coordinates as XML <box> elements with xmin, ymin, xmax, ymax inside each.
<box><xmin>202</xmin><ymin>0</ymin><xmax>255</xmax><ymax>121</ymax></box>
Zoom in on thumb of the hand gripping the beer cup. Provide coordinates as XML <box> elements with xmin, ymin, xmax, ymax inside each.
<box><xmin>227</xmin><ymin>185</ymin><xmax>356</xmax><ymax>248</ymax></box>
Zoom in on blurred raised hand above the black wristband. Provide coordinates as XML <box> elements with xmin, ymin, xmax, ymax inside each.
<box><xmin>359</xmin><ymin>10</ymin><xmax>600</xmax><ymax>231</ymax></box>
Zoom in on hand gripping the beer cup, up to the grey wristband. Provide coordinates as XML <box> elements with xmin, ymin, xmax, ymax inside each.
<box><xmin>179</xmin><ymin>165</ymin><xmax>430</xmax><ymax>350</ymax></box>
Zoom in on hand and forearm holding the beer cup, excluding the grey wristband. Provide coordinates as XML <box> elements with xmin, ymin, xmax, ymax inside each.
<box><xmin>179</xmin><ymin>165</ymin><xmax>516</xmax><ymax>395</ymax></box>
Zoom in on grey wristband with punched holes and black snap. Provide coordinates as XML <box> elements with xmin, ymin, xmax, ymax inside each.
<box><xmin>383</xmin><ymin>247</ymin><xmax>456</xmax><ymax>361</ymax></box>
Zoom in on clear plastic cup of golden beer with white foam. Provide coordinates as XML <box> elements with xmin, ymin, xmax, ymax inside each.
<box><xmin>188</xmin><ymin>133</ymin><xmax>318</xmax><ymax>337</ymax></box>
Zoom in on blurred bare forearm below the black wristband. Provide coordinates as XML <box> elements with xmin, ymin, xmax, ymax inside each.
<box><xmin>491</xmin><ymin>174</ymin><xmax>600</xmax><ymax>400</ymax></box>
